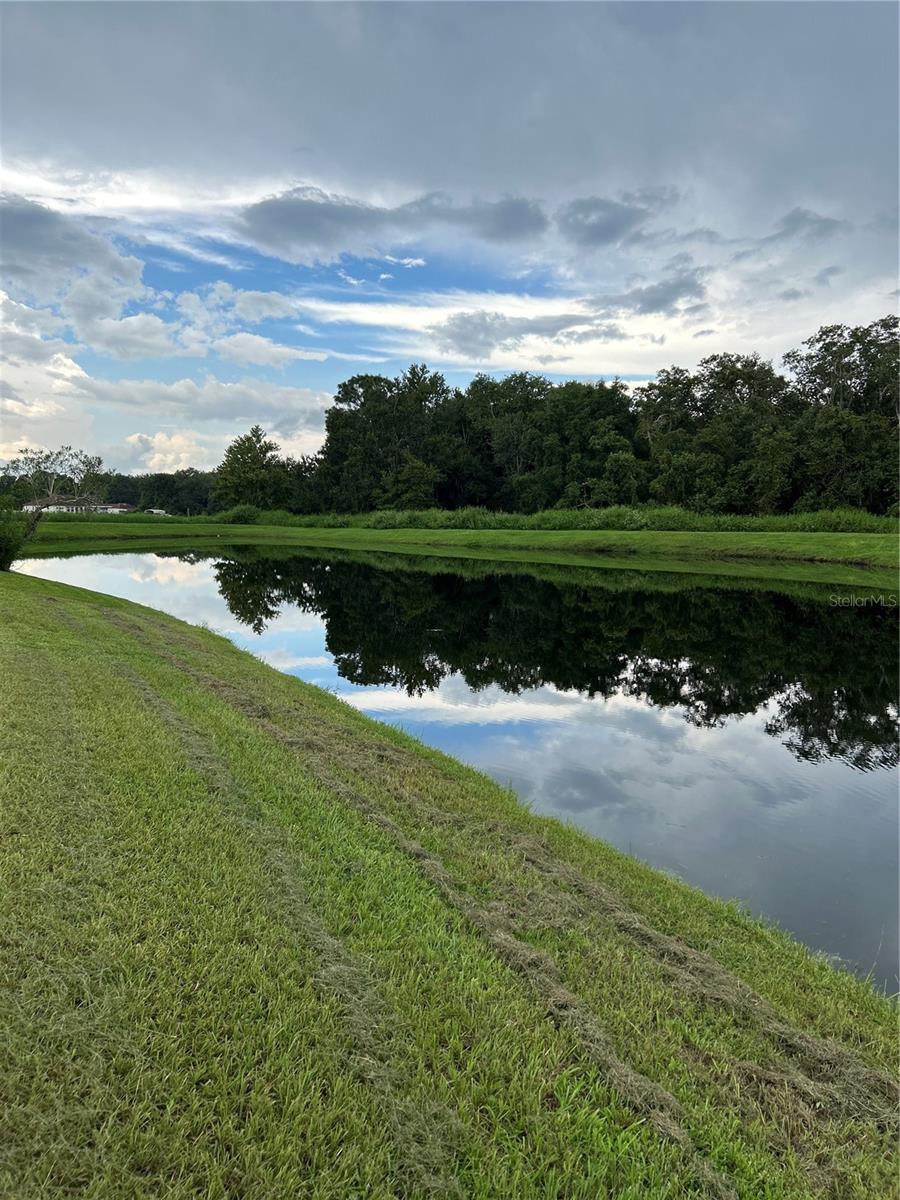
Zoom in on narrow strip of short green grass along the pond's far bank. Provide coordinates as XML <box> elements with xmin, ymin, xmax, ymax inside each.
<box><xmin>24</xmin><ymin>517</ymin><xmax>898</xmax><ymax>589</ymax></box>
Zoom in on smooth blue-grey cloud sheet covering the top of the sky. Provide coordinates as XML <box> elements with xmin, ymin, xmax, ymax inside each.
<box><xmin>2</xmin><ymin>2</ymin><xmax>898</xmax><ymax>220</ymax></box>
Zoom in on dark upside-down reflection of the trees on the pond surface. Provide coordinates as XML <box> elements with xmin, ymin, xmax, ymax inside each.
<box><xmin>192</xmin><ymin>550</ymin><xmax>898</xmax><ymax>770</ymax></box>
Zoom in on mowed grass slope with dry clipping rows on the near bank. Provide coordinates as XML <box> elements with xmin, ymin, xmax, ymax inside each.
<box><xmin>0</xmin><ymin>574</ymin><xmax>896</xmax><ymax>1200</ymax></box>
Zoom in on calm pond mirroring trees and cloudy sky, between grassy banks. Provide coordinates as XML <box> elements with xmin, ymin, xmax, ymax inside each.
<box><xmin>17</xmin><ymin>547</ymin><xmax>898</xmax><ymax>991</ymax></box>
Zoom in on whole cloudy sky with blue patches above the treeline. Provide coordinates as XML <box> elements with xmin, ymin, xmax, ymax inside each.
<box><xmin>0</xmin><ymin>0</ymin><xmax>898</xmax><ymax>472</ymax></box>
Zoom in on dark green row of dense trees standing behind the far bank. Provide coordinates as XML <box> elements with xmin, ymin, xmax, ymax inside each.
<box><xmin>3</xmin><ymin>316</ymin><xmax>900</xmax><ymax>515</ymax></box>
